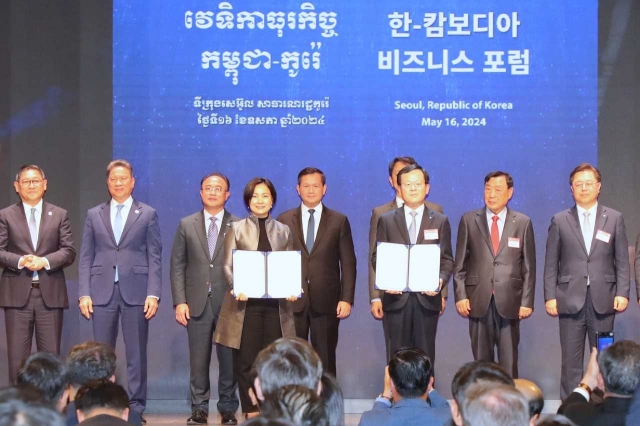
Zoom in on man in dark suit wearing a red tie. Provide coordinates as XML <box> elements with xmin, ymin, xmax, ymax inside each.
<box><xmin>454</xmin><ymin>171</ymin><xmax>536</xmax><ymax>378</ymax></box>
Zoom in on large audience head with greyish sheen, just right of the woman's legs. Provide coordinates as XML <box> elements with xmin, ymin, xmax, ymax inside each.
<box><xmin>253</xmin><ymin>337</ymin><xmax>322</xmax><ymax>400</ymax></box>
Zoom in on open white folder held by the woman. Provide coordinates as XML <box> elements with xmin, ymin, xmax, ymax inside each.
<box><xmin>233</xmin><ymin>250</ymin><xmax>302</xmax><ymax>299</ymax></box>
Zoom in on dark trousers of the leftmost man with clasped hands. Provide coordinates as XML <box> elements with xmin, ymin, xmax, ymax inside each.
<box><xmin>4</xmin><ymin>288</ymin><xmax>63</xmax><ymax>384</ymax></box>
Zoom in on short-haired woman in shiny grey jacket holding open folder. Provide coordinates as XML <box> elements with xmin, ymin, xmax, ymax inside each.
<box><xmin>213</xmin><ymin>177</ymin><xmax>296</xmax><ymax>414</ymax></box>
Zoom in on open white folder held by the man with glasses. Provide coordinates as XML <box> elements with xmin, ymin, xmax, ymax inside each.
<box><xmin>376</xmin><ymin>243</ymin><xmax>440</xmax><ymax>292</ymax></box>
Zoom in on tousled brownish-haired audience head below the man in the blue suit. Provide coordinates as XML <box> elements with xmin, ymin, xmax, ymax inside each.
<box><xmin>67</xmin><ymin>341</ymin><xmax>116</xmax><ymax>397</ymax></box>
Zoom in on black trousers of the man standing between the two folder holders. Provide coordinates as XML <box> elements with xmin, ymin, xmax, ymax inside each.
<box><xmin>294</xmin><ymin>299</ymin><xmax>340</xmax><ymax>377</ymax></box>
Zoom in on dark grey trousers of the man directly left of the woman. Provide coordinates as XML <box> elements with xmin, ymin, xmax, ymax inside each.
<box><xmin>187</xmin><ymin>296</ymin><xmax>238</xmax><ymax>413</ymax></box>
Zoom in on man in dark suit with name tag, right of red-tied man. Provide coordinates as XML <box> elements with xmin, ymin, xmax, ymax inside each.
<box><xmin>544</xmin><ymin>163</ymin><xmax>631</xmax><ymax>399</ymax></box>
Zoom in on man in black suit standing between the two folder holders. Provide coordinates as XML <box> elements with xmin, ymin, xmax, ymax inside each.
<box><xmin>278</xmin><ymin>167</ymin><xmax>356</xmax><ymax>376</ymax></box>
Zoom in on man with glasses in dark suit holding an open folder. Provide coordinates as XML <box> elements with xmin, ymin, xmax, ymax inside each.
<box><xmin>371</xmin><ymin>164</ymin><xmax>453</xmax><ymax>361</ymax></box>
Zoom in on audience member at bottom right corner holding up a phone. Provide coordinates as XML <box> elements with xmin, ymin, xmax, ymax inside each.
<box><xmin>558</xmin><ymin>340</ymin><xmax>640</xmax><ymax>426</ymax></box>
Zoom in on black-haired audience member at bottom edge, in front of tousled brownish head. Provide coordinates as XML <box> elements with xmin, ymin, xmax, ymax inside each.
<box><xmin>75</xmin><ymin>380</ymin><xmax>131</xmax><ymax>426</ymax></box>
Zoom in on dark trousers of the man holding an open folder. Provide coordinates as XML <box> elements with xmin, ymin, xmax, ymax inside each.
<box><xmin>382</xmin><ymin>294</ymin><xmax>440</xmax><ymax>365</ymax></box>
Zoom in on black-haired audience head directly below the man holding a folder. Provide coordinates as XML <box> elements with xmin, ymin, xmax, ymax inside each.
<box><xmin>389</xmin><ymin>348</ymin><xmax>433</xmax><ymax>400</ymax></box>
